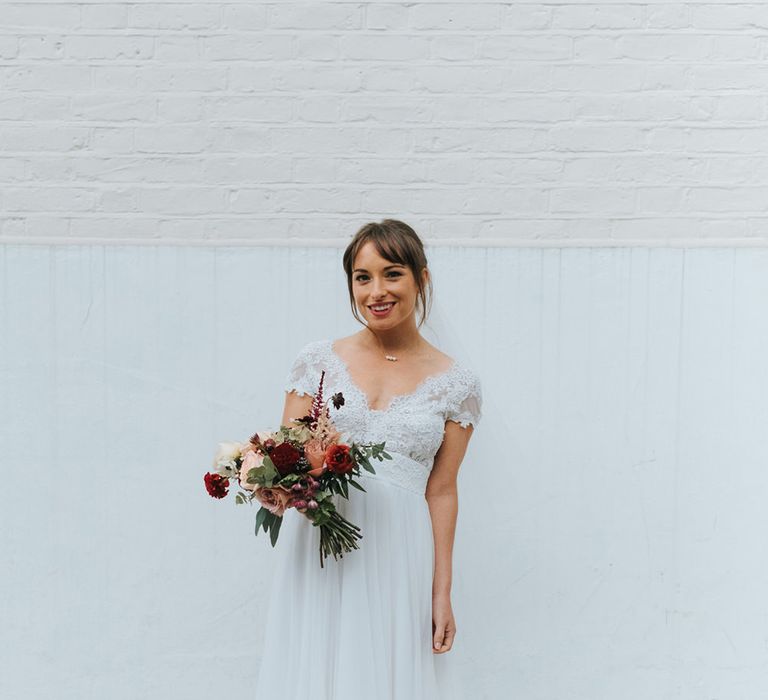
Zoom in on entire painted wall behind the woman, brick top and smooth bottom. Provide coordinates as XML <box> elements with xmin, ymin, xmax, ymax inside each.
<box><xmin>0</xmin><ymin>0</ymin><xmax>768</xmax><ymax>700</ymax></box>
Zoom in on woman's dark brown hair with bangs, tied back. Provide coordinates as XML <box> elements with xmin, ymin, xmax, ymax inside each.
<box><xmin>342</xmin><ymin>219</ymin><xmax>433</xmax><ymax>328</ymax></box>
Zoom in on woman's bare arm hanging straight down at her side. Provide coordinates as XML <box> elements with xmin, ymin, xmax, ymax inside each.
<box><xmin>425</xmin><ymin>421</ymin><xmax>474</xmax><ymax>653</ymax></box>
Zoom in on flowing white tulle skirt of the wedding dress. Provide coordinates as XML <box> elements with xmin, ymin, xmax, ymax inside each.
<box><xmin>255</xmin><ymin>453</ymin><xmax>458</xmax><ymax>700</ymax></box>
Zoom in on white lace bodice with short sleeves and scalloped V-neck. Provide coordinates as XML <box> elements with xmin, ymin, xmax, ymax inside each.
<box><xmin>285</xmin><ymin>339</ymin><xmax>482</xmax><ymax>486</ymax></box>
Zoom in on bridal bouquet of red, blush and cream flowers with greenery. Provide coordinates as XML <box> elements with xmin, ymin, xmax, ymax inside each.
<box><xmin>204</xmin><ymin>371</ymin><xmax>392</xmax><ymax>567</ymax></box>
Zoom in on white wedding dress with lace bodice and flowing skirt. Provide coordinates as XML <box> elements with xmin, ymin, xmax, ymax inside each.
<box><xmin>255</xmin><ymin>340</ymin><xmax>482</xmax><ymax>700</ymax></box>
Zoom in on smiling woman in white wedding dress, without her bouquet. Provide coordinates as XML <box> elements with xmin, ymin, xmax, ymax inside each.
<box><xmin>256</xmin><ymin>219</ymin><xmax>482</xmax><ymax>700</ymax></box>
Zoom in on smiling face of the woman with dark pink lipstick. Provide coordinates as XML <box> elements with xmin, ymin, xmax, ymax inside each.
<box><xmin>352</xmin><ymin>241</ymin><xmax>428</xmax><ymax>328</ymax></box>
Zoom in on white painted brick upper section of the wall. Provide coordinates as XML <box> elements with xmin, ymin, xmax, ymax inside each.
<box><xmin>0</xmin><ymin>0</ymin><xmax>768</xmax><ymax>245</ymax></box>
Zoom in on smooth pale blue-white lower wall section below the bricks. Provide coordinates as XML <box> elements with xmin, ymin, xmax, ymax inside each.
<box><xmin>0</xmin><ymin>245</ymin><xmax>768</xmax><ymax>700</ymax></box>
